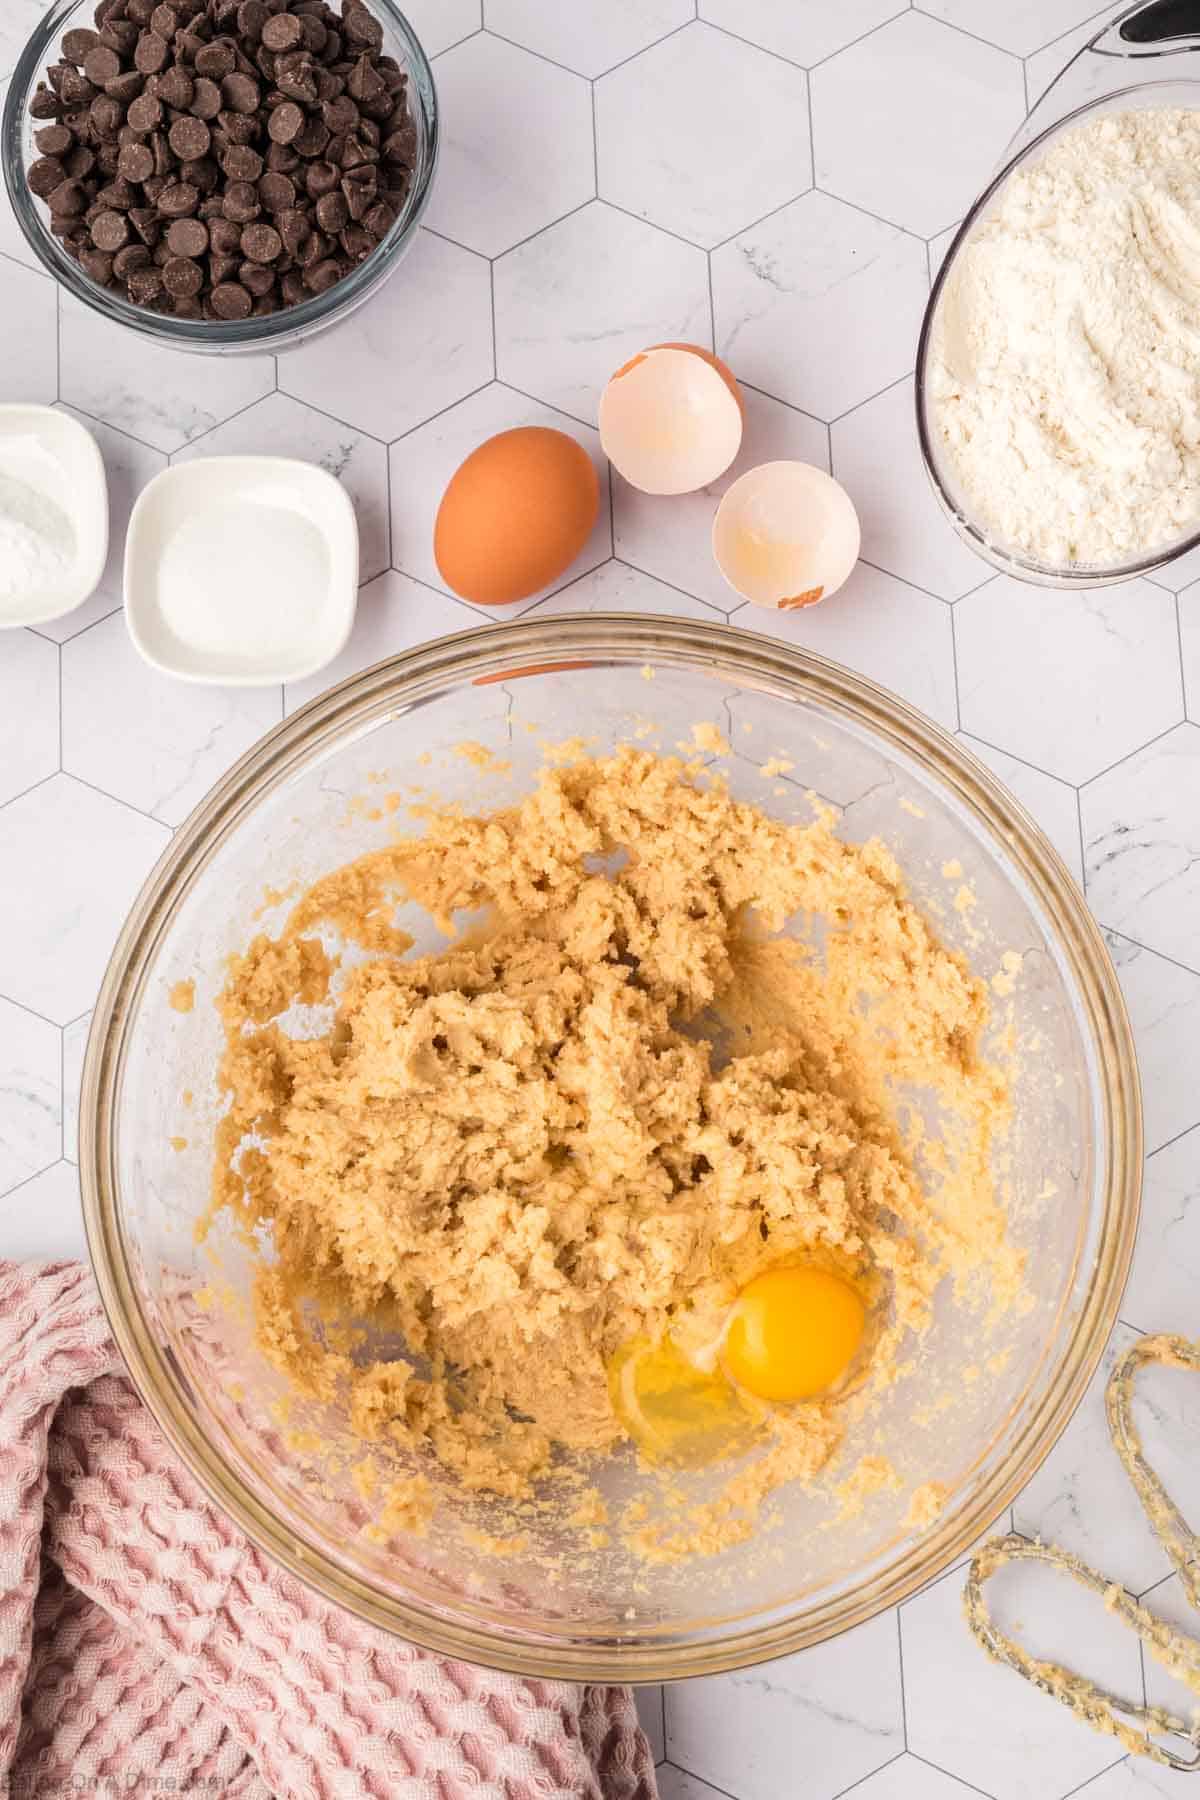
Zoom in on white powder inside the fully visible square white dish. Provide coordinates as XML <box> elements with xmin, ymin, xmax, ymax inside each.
<box><xmin>158</xmin><ymin>500</ymin><xmax>329</xmax><ymax>666</ymax></box>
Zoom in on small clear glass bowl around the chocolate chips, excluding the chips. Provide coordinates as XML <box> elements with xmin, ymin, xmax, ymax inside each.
<box><xmin>0</xmin><ymin>0</ymin><xmax>439</xmax><ymax>355</ymax></box>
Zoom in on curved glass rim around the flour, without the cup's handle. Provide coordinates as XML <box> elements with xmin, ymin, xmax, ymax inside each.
<box><xmin>912</xmin><ymin>79</ymin><xmax>1200</xmax><ymax>589</ymax></box>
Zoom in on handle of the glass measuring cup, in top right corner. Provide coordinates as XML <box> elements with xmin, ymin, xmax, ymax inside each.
<box><xmin>1004</xmin><ymin>0</ymin><xmax>1200</xmax><ymax>164</ymax></box>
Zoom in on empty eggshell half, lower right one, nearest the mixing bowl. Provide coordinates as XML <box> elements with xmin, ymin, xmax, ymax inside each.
<box><xmin>712</xmin><ymin>463</ymin><xmax>860</xmax><ymax>610</ymax></box>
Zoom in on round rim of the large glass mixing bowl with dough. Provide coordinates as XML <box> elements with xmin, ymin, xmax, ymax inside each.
<box><xmin>79</xmin><ymin>612</ymin><xmax>1142</xmax><ymax>1681</ymax></box>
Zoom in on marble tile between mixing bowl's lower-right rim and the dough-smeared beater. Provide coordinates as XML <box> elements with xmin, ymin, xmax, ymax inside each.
<box><xmin>1013</xmin><ymin>1325</ymin><xmax>1169</xmax><ymax>1593</ymax></box>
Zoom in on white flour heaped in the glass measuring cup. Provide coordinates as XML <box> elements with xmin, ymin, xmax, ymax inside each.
<box><xmin>930</xmin><ymin>108</ymin><xmax>1200</xmax><ymax>563</ymax></box>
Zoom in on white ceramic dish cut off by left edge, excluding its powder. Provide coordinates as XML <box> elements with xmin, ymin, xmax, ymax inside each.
<box><xmin>0</xmin><ymin>401</ymin><xmax>108</xmax><ymax>628</ymax></box>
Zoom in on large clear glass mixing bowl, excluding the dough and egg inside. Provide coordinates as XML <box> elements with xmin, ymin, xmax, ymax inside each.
<box><xmin>79</xmin><ymin>614</ymin><xmax>1142</xmax><ymax>1681</ymax></box>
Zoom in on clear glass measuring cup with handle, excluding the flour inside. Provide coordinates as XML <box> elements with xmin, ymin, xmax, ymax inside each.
<box><xmin>916</xmin><ymin>0</ymin><xmax>1200</xmax><ymax>589</ymax></box>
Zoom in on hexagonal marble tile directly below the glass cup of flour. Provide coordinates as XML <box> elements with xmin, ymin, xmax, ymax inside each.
<box><xmin>954</xmin><ymin>576</ymin><xmax>1184</xmax><ymax>784</ymax></box>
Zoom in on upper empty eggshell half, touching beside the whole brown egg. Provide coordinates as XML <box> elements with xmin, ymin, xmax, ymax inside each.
<box><xmin>599</xmin><ymin>344</ymin><xmax>741</xmax><ymax>493</ymax></box>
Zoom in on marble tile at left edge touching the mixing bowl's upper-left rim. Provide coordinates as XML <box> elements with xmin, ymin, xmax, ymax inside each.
<box><xmin>0</xmin><ymin>776</ymin><xmax>171</xmax><ymax>1024</ymax></box>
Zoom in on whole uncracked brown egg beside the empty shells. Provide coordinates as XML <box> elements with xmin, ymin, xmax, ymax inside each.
<box><xmin>434</xmin><ymin>425</ymin><xmax>599</xmax><ymax>607</ymax></box>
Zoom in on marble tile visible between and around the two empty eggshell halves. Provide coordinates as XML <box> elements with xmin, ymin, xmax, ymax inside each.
<box><xmin>612</xmin><ymin>387</ymin><xmax>829</xmax><ymax>612</ymax></box>
